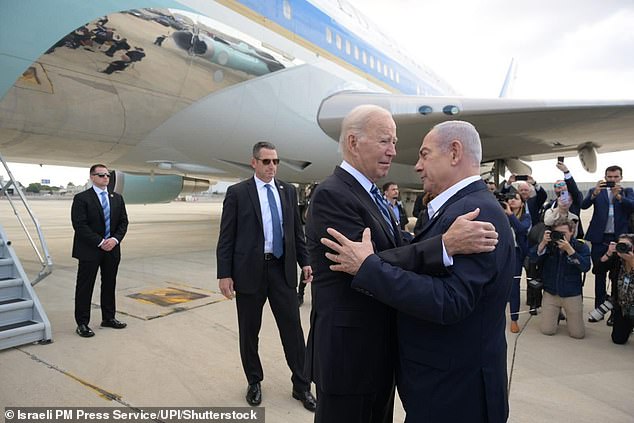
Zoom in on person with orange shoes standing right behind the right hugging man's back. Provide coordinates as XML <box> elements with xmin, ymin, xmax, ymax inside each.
<box><xmin>497</xmin><ymin>190</ymin><xmax>531</xmax><ymax>333</ymax></box>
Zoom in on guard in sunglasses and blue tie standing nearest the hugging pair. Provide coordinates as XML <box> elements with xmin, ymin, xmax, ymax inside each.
<box><xmin>216</xmin><ymin>142</ymin><xmax>316</xmax><ymax>411</ymax></box>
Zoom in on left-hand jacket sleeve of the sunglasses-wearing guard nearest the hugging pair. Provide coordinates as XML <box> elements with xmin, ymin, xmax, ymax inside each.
<box><xmin>216</xmin><ymin>187</ymin><xmax>238</xmax><ymax>279</ymax></box>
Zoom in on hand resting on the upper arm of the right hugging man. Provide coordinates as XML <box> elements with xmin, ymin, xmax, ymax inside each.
<box><xmin>442</xmin><ymin>208</ymin><xmax>498</xmax><ymax>256</ymax></box>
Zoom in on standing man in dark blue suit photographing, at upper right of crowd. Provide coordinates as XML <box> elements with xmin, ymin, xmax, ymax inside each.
<box><xmin>581</xmin><ymin>166</ymin><xmax>634</xmax><ymax>312</ymax></box>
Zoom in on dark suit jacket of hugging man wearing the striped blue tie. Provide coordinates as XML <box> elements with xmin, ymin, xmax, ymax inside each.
<box><xmin>306</xmin><ymin>167</ymin><xmax>442</xmax><ymax>395</ymax></box>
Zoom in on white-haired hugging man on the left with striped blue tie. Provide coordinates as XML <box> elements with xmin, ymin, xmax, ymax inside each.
<box><xmin>306</xmin><ymin>109</ymin><xmax>498</xmax><ymax>423</ymax></box>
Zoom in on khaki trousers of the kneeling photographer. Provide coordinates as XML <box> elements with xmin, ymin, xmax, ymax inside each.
<box><xmin>540</xmin><ymin>291</ymin><xmax>586</xmax><ymax>339</ymax></box>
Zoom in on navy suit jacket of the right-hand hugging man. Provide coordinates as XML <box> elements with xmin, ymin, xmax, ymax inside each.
<box><xmin>352</xmin><ymin>181</ymin><xmax>515</xmax><ymax>423</ymax></box>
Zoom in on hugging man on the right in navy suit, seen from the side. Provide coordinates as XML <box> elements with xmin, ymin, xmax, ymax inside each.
<box><xmin>323</xmin><ymin>121</ymin><xmax>514</xmax><ymax>423</ymax></box>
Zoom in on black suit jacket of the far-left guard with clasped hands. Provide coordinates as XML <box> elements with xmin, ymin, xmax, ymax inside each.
<box><xmin>70</xmin><ymin>187</ymin><xmax>128</xmax><ymax>260</ymax></box>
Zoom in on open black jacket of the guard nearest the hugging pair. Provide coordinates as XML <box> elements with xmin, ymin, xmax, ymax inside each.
<box><xmin>216</xmin><ymin>177</ymin><xmax>308</xmax><ymax>294</ymax></box>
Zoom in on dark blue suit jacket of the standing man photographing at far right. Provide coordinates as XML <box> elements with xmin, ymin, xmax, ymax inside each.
<box><xmin>581</xmin><ymin>188</ymin><xmax>634</xmax><ymax>244</ymax></box>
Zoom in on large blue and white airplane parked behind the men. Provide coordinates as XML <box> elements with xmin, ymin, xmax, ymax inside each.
<box><xmin>0</xmin><ymin>0</ymin><xmax>634</xmax><ymax>203</ymax></box>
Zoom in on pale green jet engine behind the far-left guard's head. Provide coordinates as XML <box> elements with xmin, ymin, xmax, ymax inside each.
<box><xmin>109</xmin><ymin>170</ymin><xmax>210</xmax><ymax>204</ymax></box>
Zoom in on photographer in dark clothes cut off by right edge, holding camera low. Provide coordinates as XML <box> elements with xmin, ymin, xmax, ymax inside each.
<box><xmin>591</xmin><ymin>234</ymin><xmax>634</xmax><ymax>344</ymax></box>
